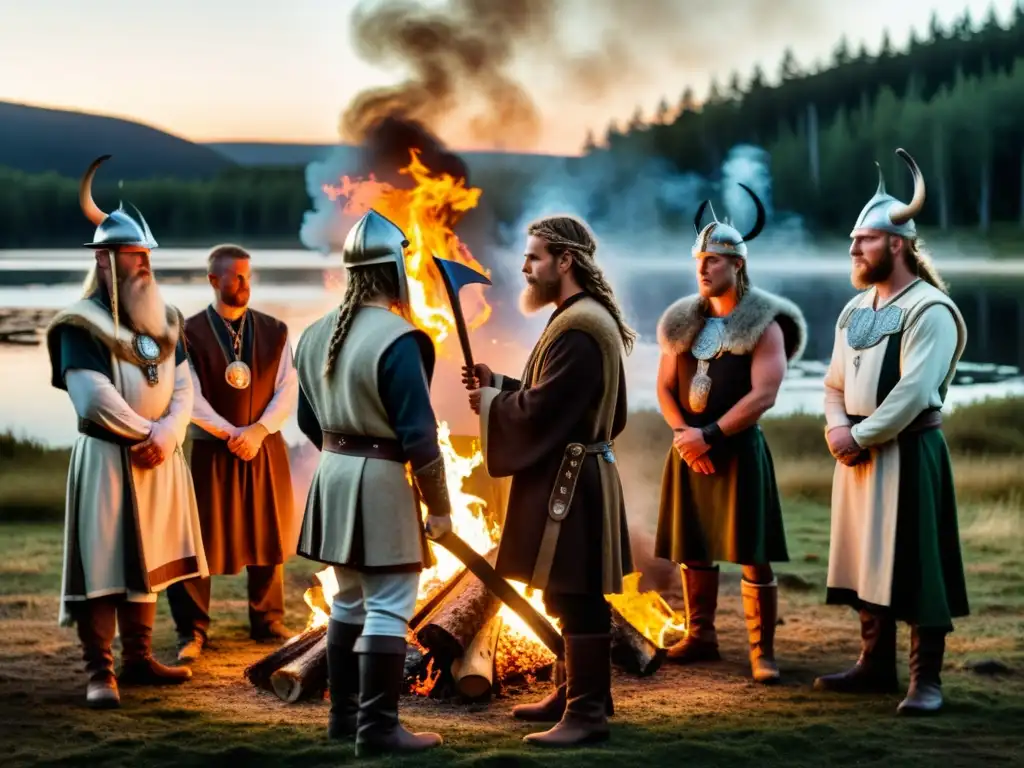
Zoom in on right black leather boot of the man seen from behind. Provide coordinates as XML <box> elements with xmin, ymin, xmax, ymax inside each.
<box><xmin>354</xmin><ymin>635</ymin><xmax>442</xmax><ymax>758</ymax></box>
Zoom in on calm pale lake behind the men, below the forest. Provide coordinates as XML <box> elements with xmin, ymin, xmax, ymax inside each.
<box><xmin>0</xmin><ymin>249</ymin><xmax>1024</xmax><ymax>445</ymax></box>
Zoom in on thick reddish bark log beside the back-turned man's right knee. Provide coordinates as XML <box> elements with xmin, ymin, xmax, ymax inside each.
<box><xmin>416</xmin><ymin>550</ymin><xmax>501</xmax><ymax>658</ymax></box>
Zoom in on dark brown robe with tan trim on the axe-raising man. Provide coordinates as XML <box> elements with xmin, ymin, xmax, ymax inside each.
<box><xmin>480</xmin><ymin>293</ymin><xmax>633</xmax><ymax>594</ymax></box>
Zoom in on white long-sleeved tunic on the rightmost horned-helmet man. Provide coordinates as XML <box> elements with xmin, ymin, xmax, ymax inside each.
<box><xmin>824</xmin><ymin>280</ymin><xmax>967</xmax><ymax>606</ymax></box>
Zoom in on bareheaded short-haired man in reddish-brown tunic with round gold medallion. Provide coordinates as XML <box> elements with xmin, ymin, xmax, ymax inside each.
<box><xmin>167</xmin><ymin>245</ymin><xmax>298</xmax><ymax>662</ymax></box>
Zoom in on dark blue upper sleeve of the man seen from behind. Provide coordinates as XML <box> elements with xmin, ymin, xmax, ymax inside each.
<box><xmin>377</xmin><ymin>334</ymin><xmax>440</xmax><ymax>472</ymax></box>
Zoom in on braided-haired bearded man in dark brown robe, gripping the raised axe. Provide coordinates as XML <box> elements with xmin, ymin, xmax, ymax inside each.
<box><xmin>463</xmin><ymin>216</ymin><xmax>636</xmax><ymax>746</ymax></box>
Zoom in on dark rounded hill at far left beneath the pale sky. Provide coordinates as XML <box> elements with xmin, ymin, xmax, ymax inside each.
<box><xmin>0</xmin><ymin>101</ymin><xmax>236</xmax><ymax>180</ymax></box>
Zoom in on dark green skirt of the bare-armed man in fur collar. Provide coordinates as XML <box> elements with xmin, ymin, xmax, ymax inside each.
<box><xmin>654</xmin><ymin>426</ymin><xmax>790</xmax><ymax>565</ymax></box>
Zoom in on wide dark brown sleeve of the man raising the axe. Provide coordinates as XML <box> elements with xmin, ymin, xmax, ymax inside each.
<box><xmin>480</xmin><ymin>331</ymin><xmax>603</xmax><ymax>477</ymax></box>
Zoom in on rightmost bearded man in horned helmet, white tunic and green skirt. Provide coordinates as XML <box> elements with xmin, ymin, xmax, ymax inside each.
<box><xmin>815</xmin><ymin>150</ymin><xmax>969</xmax><ymax>715</ymax></box>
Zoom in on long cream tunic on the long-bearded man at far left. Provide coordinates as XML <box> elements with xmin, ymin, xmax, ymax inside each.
<box><xmin>51</xmin><ymin>300</ymin><xmax>209</xmax><ymax>625</ymax></box>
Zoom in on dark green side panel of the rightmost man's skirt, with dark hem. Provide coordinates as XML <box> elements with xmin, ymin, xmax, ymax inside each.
<box><xmin>825</xmin><ymin>429</ymin><xmax>970</xmax><ymax>631</ymax></box>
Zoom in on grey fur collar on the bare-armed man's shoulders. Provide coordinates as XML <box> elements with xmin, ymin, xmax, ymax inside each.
<box><xmin>657</xmin><ymin>288</ymin><xmax>807</xmax><ymax>362</ymax></box>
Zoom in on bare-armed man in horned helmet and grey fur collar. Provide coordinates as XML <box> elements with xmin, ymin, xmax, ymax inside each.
<box><xmin>654</xmin><ymin>185</ymin><xmax>807</xmax><ymax>683</ymax></box>
